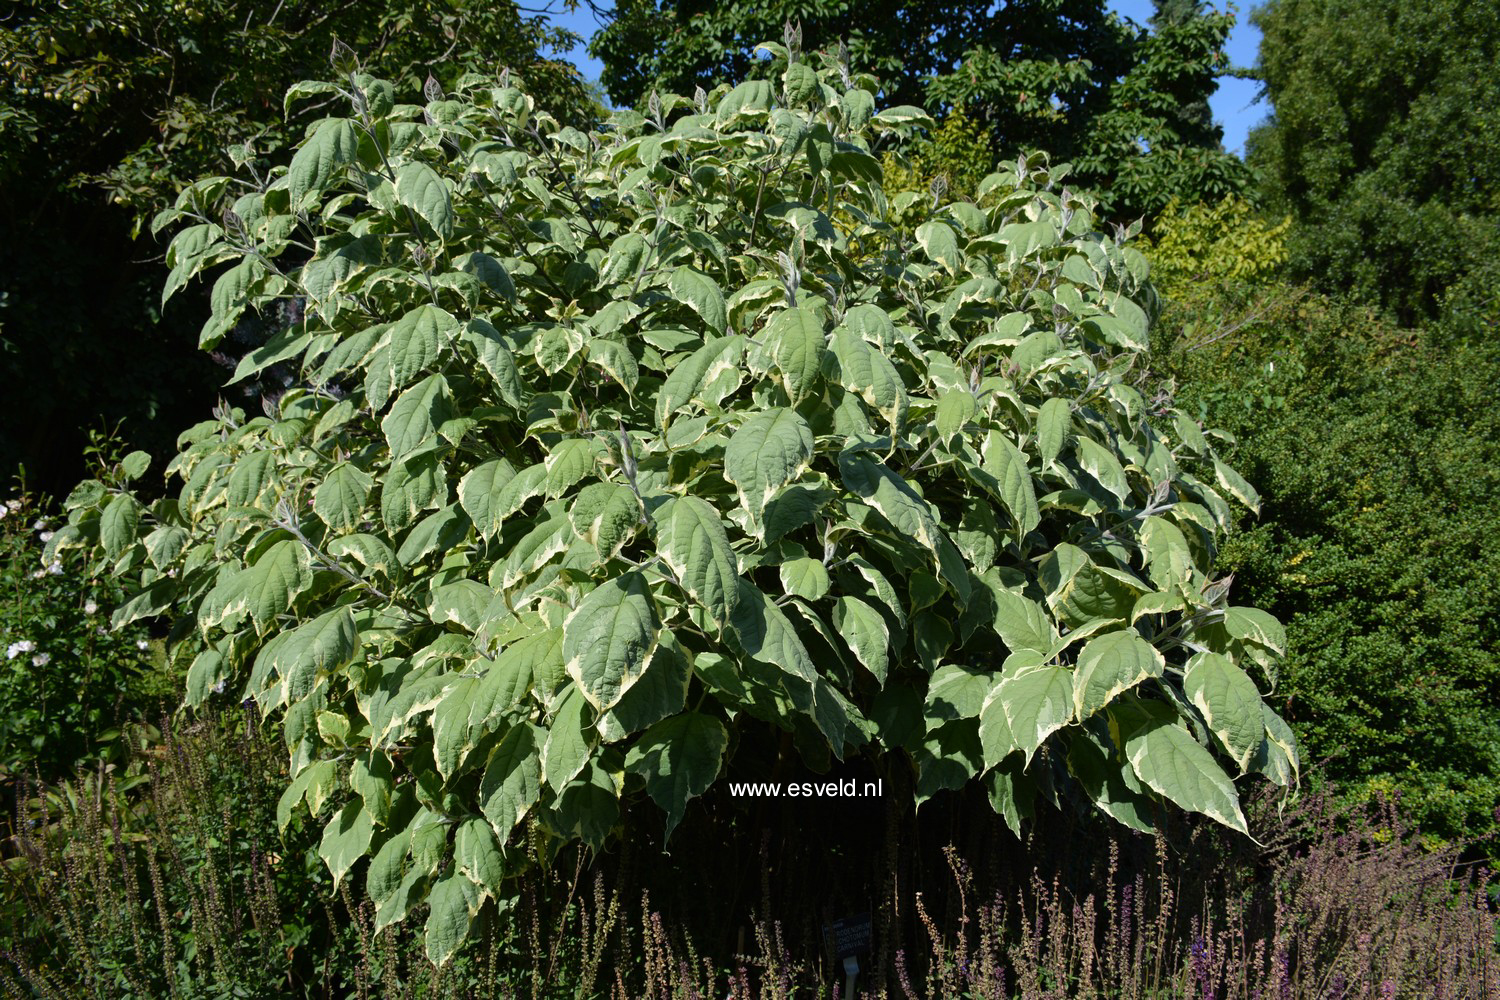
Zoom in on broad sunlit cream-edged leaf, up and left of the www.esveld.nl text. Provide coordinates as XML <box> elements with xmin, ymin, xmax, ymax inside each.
<box><xmin>563</xmin><ymin>573</ymin><xmax>660</xmax><ymax>712</ymax></box>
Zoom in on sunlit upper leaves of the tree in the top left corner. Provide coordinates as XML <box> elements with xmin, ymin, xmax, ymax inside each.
<box><xmin>0</xmin><ymin>0</ymin><xmax>593</xmax><ymax>226</ymax></box>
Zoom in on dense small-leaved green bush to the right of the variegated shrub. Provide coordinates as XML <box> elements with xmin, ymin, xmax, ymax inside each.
<box><xmin>1157</xmin><ymin>298</ymin><xmax>1500</xmax><ymax>837</ymax></box>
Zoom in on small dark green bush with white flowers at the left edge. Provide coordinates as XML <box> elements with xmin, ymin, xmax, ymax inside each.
<box><xmin>0</xmin><ymin>485</ymin><xmax>171</xmax><ymax>781</ymax></box>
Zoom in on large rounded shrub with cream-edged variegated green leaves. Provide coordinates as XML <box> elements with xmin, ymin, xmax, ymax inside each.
<box><xmin>51</xmin><ymin>46</ymin><xmax>1298</xmax><ymax>963</ymax></box>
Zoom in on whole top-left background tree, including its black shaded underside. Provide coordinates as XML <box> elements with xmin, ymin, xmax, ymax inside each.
<box><xmin>0</xmin><ymin>0</ymin><xmax>593</xmax><ymax>492</ymax></box>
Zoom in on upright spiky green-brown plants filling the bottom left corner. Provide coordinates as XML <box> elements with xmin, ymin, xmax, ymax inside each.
<box><xmin>0</xmin><ymin>711</ymin><xmax>402</xmax><ymax>1000</ymax></box>
